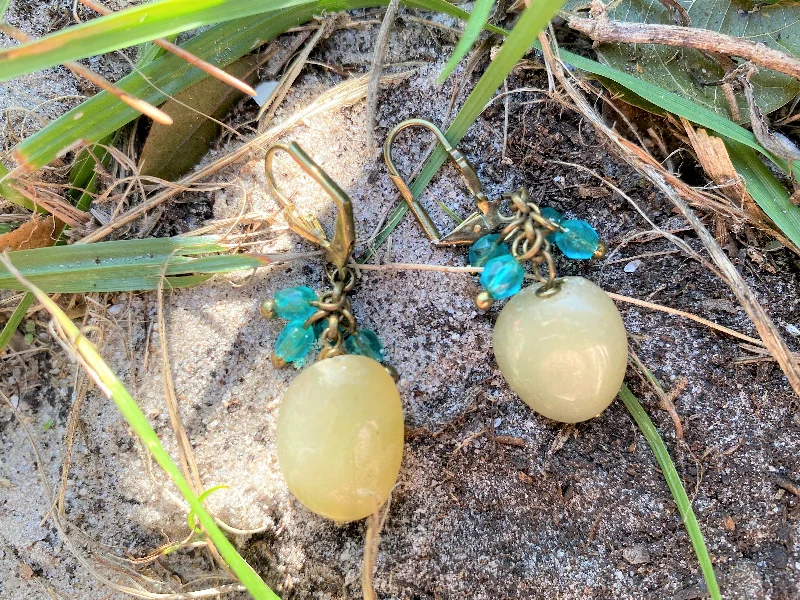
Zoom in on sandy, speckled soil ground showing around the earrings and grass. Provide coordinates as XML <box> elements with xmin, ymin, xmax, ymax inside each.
<box><xmin>0</xmin><ymin>1</ymin><xmax>800</xmax><ymax>600</ymax></box>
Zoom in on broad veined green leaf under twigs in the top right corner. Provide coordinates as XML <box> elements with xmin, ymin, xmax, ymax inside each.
<box><xmin>567</xmin><ymin>0</ymin><xmax>800</xmax><ymax>122</ymax></box>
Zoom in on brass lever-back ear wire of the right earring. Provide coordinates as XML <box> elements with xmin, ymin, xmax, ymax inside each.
<box><xmin>383</xmin><ymin>119</ymin><xmax>513</xmax><ymax>246</ymax></box>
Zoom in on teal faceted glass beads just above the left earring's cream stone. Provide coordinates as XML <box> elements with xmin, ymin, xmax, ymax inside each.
<box><xmin>265</xmin><ymin>286</ymin><xmax>386</xmax><ymax>365</ymax></box>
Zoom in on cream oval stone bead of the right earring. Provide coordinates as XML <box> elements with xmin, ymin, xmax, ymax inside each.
<box><xmin>493</xmin><ymin>277</ymin><xmax>628</xmax><ymax>423</ymax></box>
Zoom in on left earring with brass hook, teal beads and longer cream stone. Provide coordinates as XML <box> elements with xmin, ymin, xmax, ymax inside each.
<box><xmin>261</xmin><ymin>142</ymin><xmax>404</xmax><ymax>522</ymax></box>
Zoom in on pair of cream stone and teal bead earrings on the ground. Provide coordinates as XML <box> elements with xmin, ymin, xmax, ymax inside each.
<box><xmin>261</xmin><ymin>119</ymin><xmax>627</xmax><ymax>521</ymax></box>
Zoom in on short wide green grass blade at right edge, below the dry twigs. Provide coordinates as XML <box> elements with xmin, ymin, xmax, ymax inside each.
<box><xmin>725</xmin><ymin>140</ymin><xmax>800</xmax><ymax>246</ymax></box>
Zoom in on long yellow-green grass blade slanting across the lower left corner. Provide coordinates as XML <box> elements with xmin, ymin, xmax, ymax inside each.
<box><xmin>4</xmin><ymin>261</ymin><xmax>280</xmax><ymax>600</ymax></box>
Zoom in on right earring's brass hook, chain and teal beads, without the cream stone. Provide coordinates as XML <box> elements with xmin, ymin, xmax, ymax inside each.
<box><xmin>384</xmin><ymin>119</ymin><xmax>606</xmax><ymax>310</ymax></box>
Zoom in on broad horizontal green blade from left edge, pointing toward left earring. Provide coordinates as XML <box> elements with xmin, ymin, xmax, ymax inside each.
<box><xmin>0</xmin><ymin>237</ymin><xmax>264</xmax><ymax>293</ymax></box>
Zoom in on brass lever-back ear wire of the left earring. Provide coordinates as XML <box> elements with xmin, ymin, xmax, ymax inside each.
<box><xmin>264</xmin><ymin>142</ymin><xmax>356</xmax><ymax>270</ymax></box>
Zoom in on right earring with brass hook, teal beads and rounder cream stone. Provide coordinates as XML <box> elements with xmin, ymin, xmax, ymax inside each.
<box><xmin>383</xmin><ymin>119</ymin><xmax>628</xmax><ymax>423</ymax></box>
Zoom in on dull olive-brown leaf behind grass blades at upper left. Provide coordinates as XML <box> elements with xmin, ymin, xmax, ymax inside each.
<box><xmin>139</xmin><ymin>55</ymin><xmax>262</xmax><ymax>181</ymax></box>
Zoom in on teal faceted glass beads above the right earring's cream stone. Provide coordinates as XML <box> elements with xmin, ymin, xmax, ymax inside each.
<box><xmin>469</xmin><ymin>207</ymin><xmax>600</xmax><ymax>300</ymax></box>
